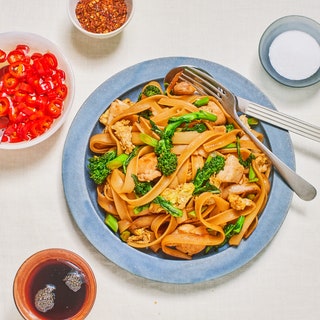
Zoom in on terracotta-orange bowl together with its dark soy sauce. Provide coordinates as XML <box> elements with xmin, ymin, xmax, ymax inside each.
<box><xmin>13</xmin><ymin>248</ymin><xmax>96</xmax><ymax>320</ymax></box>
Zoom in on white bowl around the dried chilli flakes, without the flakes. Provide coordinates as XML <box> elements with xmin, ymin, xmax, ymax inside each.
<box><xmin>68</xmin><ymin>0</ymin><xmax>133</xmax><ymax>39</ymax></box>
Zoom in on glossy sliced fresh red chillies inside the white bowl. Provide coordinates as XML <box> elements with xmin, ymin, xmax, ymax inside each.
<box><xmin>0</xmin><ymin>44</ymin><xmax>68</xmax><ymax>143</ymax></box>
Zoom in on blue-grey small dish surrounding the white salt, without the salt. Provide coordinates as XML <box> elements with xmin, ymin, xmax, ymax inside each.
<box><xmin>259</xmin><ymin>15</ymin><xmax>320</xmax><ymax>88</ymax></box>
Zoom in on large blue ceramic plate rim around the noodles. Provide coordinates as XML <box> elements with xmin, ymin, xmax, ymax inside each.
<box><xmin>62</xmin><ymin>57</ymin><xmax>295</xmax><ymax>283</ymax></box>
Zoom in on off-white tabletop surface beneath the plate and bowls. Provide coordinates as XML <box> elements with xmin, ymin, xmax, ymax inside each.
<box><xmin>0</xmin><ymin>0</ymin><xmax>320</xmax><ymax>320</ymax></box>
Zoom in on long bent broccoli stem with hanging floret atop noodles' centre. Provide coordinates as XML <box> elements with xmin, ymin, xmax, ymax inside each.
<box><xmin>140</xmin><ymin>110</ymin><xmax>217</xmax><ymax>176</ymax></box>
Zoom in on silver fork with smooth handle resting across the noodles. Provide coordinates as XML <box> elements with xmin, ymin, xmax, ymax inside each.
<box><xmin>179</xmin><ymin>66</ymin><xmax>317</xmax><ymax>200</ymax></box>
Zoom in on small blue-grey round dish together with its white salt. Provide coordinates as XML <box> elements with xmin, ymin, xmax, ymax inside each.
<box><xmin>259</xmin><ymin>15</ymin><xmax>320</xmax><ymax>88</ymax></box>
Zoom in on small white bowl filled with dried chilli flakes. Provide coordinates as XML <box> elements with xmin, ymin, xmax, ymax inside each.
<box><xmin>68</xmin><ymin>0</ymin><xmax>133</xmax><ymax>39</ymax></box>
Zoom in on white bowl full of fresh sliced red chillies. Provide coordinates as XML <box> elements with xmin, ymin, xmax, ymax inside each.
<box><xmin>0</xmin><ymin>32</ymin><xmax>74</xmax><ymax>149</ymax></box>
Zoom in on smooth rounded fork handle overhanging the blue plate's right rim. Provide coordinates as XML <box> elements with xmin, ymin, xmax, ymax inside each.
<box><xmin>238</xmin><ymin>121</ymin><xmax>317</xmax><ymax>201</ymax></box>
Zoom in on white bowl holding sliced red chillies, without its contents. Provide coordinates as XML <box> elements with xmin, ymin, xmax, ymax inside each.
<box><xmin>0</xmin><ymin>32</ymin><xmax>74</xmax><ymax>149</ymax></box>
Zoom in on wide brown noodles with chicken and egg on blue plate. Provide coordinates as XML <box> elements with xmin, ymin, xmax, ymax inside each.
<box><xmin>89</xmin><ymin>78</ymin><xmax>271</xmax><ymax>259</ymax></box>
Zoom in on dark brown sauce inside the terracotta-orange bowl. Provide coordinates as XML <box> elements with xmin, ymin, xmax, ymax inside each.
<box><xmin>27</xmin><ymin>259</ymin><xmax>87</xmax><ymax>320</ymax></box>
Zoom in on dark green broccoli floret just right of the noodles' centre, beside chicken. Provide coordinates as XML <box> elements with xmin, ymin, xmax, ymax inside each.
<box><xmin>193</xmin><ymin>155</ymin><xmax>225</xmax><ymax>194</ymax></box>
